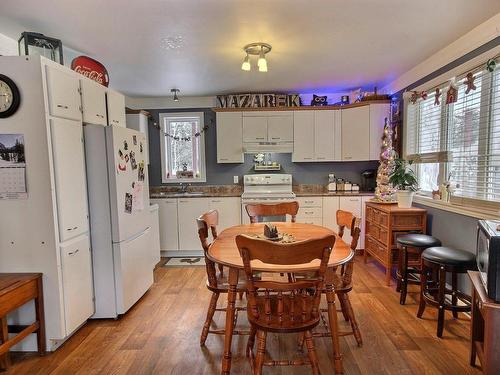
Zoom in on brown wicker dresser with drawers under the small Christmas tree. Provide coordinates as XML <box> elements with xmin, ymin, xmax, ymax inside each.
<box><xmin>364</xmin><ymin>202</ymin><xmax>427</xmax><ymax>285</ymax></box>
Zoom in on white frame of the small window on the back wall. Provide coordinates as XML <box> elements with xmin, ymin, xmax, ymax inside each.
<box><xmin>159</xmin><ymin>112</ymin><xmax>207</xmax><ymax>184</ymax></box>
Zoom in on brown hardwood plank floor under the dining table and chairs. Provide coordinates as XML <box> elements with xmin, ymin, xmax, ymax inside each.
<box><xmin>4</xmin><ymin>258</ymin><xmax>480</xmax><ymax>375</ymax></box>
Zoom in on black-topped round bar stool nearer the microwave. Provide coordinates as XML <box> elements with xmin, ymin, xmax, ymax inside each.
<box><xmin>417</xmin><ymin>247</ymin><xmax>476</xmax><ymax>337</ymax></box>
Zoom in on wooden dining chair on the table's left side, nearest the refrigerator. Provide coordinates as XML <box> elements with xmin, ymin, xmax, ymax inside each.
<box><xmin>196</xmin><ymin>210</ymin><xmax>249</xmax><ymax>346</ymax></box>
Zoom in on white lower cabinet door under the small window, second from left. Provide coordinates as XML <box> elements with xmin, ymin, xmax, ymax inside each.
<box><xmin>178</xmin><ymin>198</ymin><xmax>208</xmax><ymax>250</ymax></box>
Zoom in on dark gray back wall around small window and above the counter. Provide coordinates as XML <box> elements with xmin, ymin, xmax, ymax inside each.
<box><xmin>148</xmin><ymin>108</ymin><xmax>378</xmax><ymax>186</ymax></box>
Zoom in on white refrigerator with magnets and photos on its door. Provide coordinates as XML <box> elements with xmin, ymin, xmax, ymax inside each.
<box><xmin>84</xmin><ymin>125</ymin><xmax>153</xmax><ymax>318</ymax></box>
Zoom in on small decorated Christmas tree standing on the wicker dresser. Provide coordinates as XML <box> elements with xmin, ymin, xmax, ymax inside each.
<box><xmin>375</xmin><ymin>118</ymin><xmax>397</xmax><ymax>202</ymax></box>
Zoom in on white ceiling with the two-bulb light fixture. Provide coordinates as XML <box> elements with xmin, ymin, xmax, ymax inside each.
<box><xmin>0</xmin><ymin>0</ymin><xmax>500</xmax><ymax>96</ymax></box>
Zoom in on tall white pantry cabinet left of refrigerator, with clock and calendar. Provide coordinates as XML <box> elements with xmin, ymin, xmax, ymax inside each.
<box><xmin>0</xmin><ymin>56</ymin><xmax>94</xmax><ymax>350</ymax></box>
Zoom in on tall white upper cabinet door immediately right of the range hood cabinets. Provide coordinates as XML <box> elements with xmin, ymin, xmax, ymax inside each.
<box><xmin>292</xmin><ymin>111</ymin><xmax>314</xmax><ymax>162</ymax></box>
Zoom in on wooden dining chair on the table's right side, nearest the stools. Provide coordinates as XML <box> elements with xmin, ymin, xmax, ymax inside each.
<box><xmin>314</xmin><ymin>210</ymin><xmax>363</xmax><ymax>346</ymax></box>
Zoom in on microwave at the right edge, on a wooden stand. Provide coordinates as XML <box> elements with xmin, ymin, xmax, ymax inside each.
<box><xmin>476</xmin><ymin>220</ymin><xmax>500</xmax><ymax>302</ymax></box>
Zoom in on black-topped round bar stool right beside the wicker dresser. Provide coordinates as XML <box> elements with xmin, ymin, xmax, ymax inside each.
<box><xmin>396</xmin><ymin>233</ymin><xmax>441</xmax><ymax>305</ymax></box>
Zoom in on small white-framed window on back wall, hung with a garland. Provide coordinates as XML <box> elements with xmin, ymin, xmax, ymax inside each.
<box><xmin>160</xmin><ymin>112</ymin><xmax>206</xmax><ymax>183</ymax></box>
